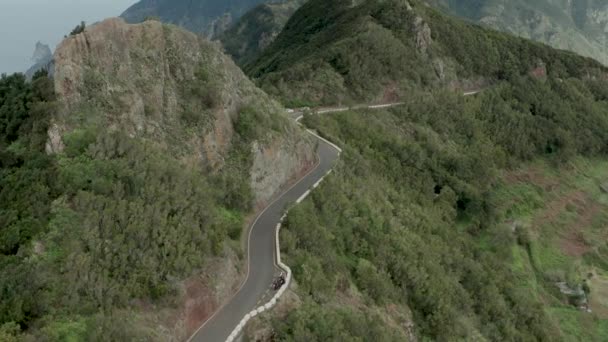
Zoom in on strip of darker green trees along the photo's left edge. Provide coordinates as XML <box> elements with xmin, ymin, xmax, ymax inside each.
<box><xmin>0</xmin><ymin>73</ymin><xmax>56</xmax><ymax>336</ymax></box>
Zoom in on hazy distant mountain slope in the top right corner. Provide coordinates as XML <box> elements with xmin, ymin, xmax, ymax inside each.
<box><xmin>429</xmin><ymin>0</ymin><xmax>608</xmax><ymax>65</ymax></box>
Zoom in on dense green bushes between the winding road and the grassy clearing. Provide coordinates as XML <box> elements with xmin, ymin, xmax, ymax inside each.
<box><xmin>273</xmin><ymin>71</ymin><xmax>608</xmax><ymax>341</ymax></box>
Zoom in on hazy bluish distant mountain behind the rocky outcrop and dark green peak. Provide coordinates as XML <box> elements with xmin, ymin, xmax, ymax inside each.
<box><xmin>121</xmin><ymin>0</ymin><xmax>282</xmax><ymax>38</ymax></box>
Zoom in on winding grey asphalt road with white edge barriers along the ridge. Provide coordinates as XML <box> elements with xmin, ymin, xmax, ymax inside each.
<box><xmin>188</xmin><ymin>92</ymin><xmax>477</xmax><ymax>342</ymax></box>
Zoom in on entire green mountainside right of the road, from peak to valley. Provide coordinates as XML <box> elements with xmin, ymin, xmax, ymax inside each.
<box><xmin>240</xmin><ymin>0</ymin><xmax>608</xmax><ymax>341</ymax></box>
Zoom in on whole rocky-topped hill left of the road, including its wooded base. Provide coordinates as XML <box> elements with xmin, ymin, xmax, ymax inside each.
<box><xmin>0</xmin><ymin>19</ymin><xmax>315</xmax><ymax>341</ymax></box>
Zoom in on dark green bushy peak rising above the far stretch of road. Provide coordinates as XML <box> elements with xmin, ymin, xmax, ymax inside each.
<box><xmin>247</xmin><ymin>0</ymin><xmax>605</xmax><ymax>105</ymax></box>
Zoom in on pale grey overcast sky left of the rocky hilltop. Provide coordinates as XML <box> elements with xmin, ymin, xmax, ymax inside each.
<box><xmin>0</xmin><ymin>0</ymin><xmax>137</xmax><ymax>73</ymax></box>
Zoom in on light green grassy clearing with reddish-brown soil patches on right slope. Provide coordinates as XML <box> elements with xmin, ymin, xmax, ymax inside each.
<box><xmin>493</xmin><ymin>158</ymin><xmax>608</xmax><ymax>341</ymax></box>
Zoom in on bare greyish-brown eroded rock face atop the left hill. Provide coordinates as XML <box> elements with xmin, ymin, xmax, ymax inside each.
<box><xmin>47</xmin><ymin>19</ymin><xmax>314</xmax><ymax>202</ymax></box>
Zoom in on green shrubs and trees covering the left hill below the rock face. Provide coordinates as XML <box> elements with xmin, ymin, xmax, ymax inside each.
<box><xmin>0</xmin><ymin>70</ymin><xmax>258</xmax><ymax>341</ymax></box>
